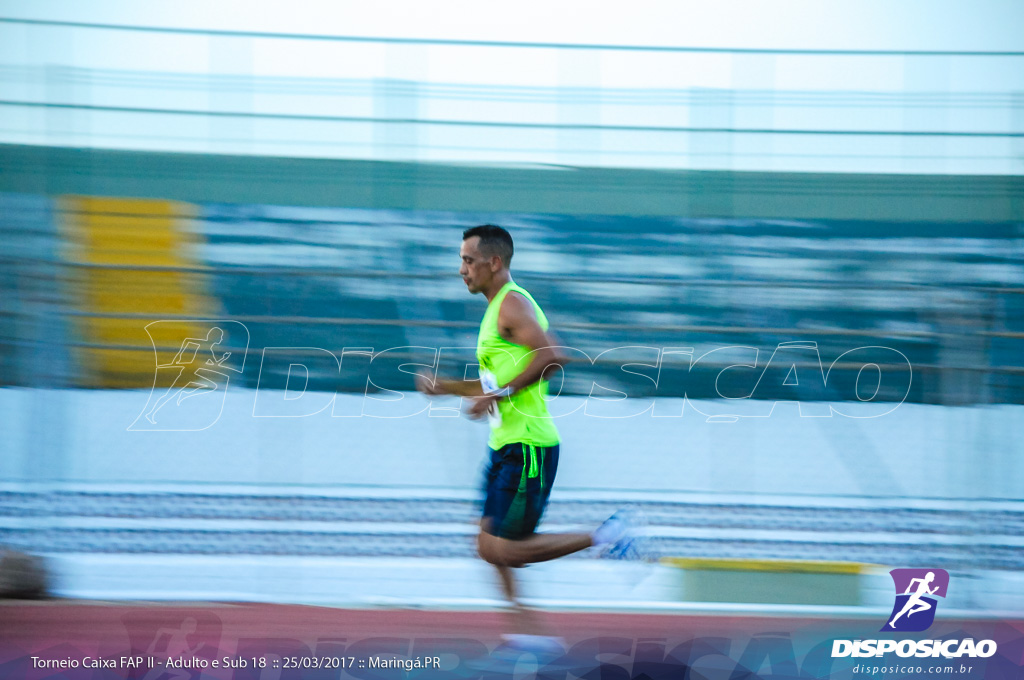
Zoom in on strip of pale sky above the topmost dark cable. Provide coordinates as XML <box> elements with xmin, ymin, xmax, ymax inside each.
<box><xmin>0</xmin><ymin>0</ymin><xmax>1024</xmax><ymax>51</ymax></box>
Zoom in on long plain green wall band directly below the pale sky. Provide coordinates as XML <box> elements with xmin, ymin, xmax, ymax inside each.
<box><xmin>0</xmin><ymin>145</ymin><xmax>1024</xmax><ymax>221</ymax></box>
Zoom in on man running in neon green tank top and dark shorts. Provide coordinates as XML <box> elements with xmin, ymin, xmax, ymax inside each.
<box><xmin>417</xmin><ymin>224</ymin><xmax>636</xmax><ymax>635</ymax></box>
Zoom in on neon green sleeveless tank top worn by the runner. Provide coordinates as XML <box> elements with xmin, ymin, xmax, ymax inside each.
<box><xmin>476</xmin><ymin>282</ymin><xmax>558</xmax><ymax>449</ymax></box>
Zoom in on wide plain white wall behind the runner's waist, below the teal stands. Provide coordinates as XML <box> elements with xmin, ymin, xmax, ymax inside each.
<box><xmin>0</xmin><ymin>386</ymin><xmax>1024</xmax><ymax>500</ymax></box>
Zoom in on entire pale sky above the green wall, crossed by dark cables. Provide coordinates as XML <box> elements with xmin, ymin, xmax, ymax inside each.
<box><xmin>0</xmin><ymin>0</ymin><xmax>1024</xmax><ymax>174</ymax></box>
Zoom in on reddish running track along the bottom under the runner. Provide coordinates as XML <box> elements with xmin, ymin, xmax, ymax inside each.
<box><xmin>0</xmin><ymin>601</ymin><xmax>1024</xmax><ymax>680</ymax></box>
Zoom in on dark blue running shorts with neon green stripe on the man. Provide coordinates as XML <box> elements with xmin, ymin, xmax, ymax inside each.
<box><xmin>482</xmin><ymin>443</ymin><xmax>558</xmax><ymax>540</ymax></box>
